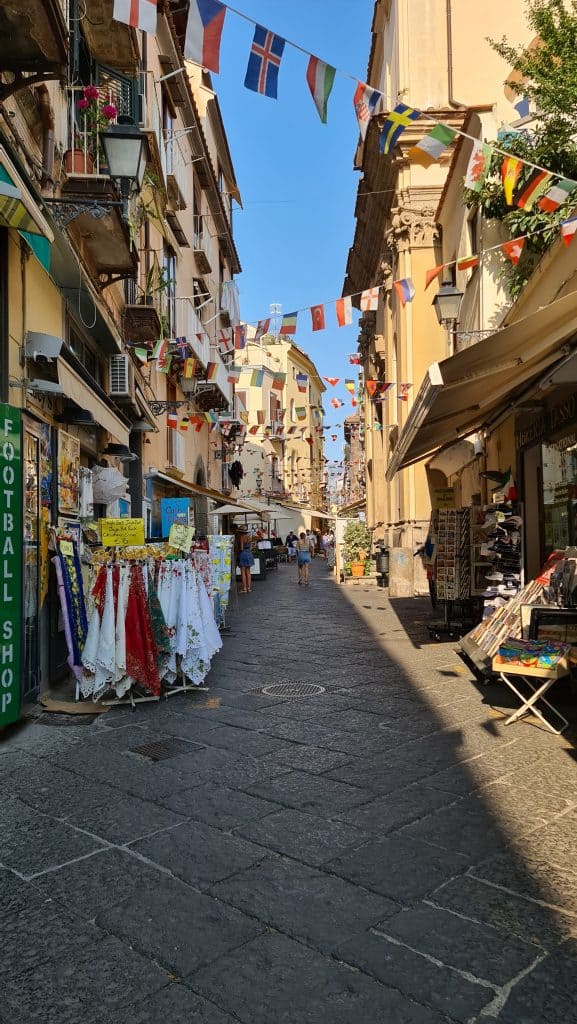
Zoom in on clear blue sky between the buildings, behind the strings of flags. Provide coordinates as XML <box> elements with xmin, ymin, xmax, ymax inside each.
<box><xmin>212</xmin><ymin>0</ymin><xmax>373</xmax><ymax>459</ymax></box>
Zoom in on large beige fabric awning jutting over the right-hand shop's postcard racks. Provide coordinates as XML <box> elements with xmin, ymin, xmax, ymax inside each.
<box><xmin>386</xmin><ymin>295</ymin><xmax>577</xmax><ymax>480</ymax></box>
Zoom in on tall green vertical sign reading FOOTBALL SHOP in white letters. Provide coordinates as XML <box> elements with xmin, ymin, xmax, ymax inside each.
<box><xmin>0</xmin><ymin>402</ymin><xmax>23</xmax><ymax>728</ymax></box>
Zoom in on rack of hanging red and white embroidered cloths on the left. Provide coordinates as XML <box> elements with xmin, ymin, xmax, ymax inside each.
<box><xmin>52</xmin><ymin>520</ymin><xmax>232</xmax><ymax>706</ymax></box>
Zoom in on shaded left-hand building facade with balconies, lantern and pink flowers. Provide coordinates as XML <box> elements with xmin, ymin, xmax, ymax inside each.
<box><xmin>0</xmin><ymin>0</ymin><xmax>240</xmax><ymax>699</ymax></box>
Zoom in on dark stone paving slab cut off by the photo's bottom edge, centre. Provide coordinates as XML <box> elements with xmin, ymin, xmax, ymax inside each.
<box><xmin>191</xmin><ymin>935</ymin><xmax>443</xmax><ymax>1024</ymax></box>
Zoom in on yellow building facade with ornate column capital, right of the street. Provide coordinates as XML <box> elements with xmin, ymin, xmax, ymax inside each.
<box><xmin>343</xmin><ymin>0</ymin><xmax>527</xmax><ymax>595</ymax></box>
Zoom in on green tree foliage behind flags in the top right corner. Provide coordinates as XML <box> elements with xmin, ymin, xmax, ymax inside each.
<box><xmin>464</xmin><ymin>0</ymin><xmax>577</xmax><ymax>298</ymax></box>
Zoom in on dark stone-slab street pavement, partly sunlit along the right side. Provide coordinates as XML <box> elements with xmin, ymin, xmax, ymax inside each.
<box><xmin>0</xmin><ymin>562</ymin><xmax>577</xmax><ymax>1024</ymax></box>
